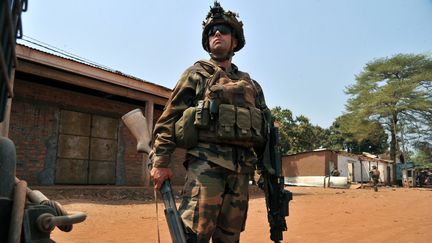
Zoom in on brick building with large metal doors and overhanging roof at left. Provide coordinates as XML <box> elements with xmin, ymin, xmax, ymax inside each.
<box><xmin>8</xmin><ymin>45</ymin><xmax>184</xmax><ymax>185</ymax></box>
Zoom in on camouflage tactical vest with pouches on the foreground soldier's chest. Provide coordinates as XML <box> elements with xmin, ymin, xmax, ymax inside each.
<box><xmin>176</xmin><ymin>61</ymin><xmax>265</xmax><ymax>148</ymax></box>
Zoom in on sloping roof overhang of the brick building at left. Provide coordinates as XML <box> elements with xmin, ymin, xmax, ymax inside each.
<box><xmin>16</xmin><ymin>45</ymin><xmax>171</xmax><ymax>106</ymax></box>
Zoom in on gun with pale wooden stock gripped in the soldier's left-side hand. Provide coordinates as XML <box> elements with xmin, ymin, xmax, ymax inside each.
<box><xmin>122</xmin><ymin>109</ymin><xmax>186</xmax><ymax>243</ymax></box>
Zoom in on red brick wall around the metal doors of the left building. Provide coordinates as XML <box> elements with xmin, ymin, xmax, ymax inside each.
<box><xmin>9</xmin><ymin>80</ymin><xmax>172</xmax><ymax>185</ymax></box>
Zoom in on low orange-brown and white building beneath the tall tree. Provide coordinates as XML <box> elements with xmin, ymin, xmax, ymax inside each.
<box><xmin>282</xmin><ymin>149</ymin><xmax>392</xmax><ymax>187</ymax></box>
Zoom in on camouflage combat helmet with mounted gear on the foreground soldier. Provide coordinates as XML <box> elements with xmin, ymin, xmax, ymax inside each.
<box><xmin>202</xmin><ymin>1</ymin><xmax>246</xmax><ymax>53</ymax></box>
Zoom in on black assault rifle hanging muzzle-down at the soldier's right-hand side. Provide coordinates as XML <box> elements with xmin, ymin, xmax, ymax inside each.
<box><xmin>258</xmin><ymin>119</ymin><xmax>292</xmax><ymax>243</ymax></box>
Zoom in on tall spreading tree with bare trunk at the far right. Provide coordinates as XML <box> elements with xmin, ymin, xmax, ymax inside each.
<box><xmin>346</xmin><ymin>54</ymin><xmax>432</xmax><ymax>181</ymax></box>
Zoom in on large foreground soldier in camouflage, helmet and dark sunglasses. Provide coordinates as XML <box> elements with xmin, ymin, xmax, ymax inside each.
<box><xmin>149</xmin><ymin>1</ymin><xmax>270</xmax><ymax>242</ymax></box>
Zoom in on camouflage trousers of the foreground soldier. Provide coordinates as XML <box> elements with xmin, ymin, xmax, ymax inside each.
<box><xmin>179</xmin><ymin>157</ymin><xmax>249</xmax><ymax>243</ymax></box>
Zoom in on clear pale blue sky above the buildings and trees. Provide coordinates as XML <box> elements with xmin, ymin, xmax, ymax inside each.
<box><xmin>20</xmin><ymin>0</ymin><xmax>432</xmax><ymax>128</ymax></box>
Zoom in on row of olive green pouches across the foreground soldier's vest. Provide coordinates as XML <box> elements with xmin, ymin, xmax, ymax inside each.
<box><xmin>175</xmin><ymin>100</ymin><xmax>265</xmax><ymax>149</ymax></box>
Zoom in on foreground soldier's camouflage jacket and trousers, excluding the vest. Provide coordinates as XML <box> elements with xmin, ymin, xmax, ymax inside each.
<box><xmin>151</xmin><ymin>59</ymin><xmax>269</xmax><ymax>242</ymax></box>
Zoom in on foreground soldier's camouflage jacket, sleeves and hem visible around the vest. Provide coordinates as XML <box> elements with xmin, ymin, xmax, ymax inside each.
<box><xmin>150</xmin><ymin>59</ymin><xmax>270</xmax><ymax>173</ymax></box>
